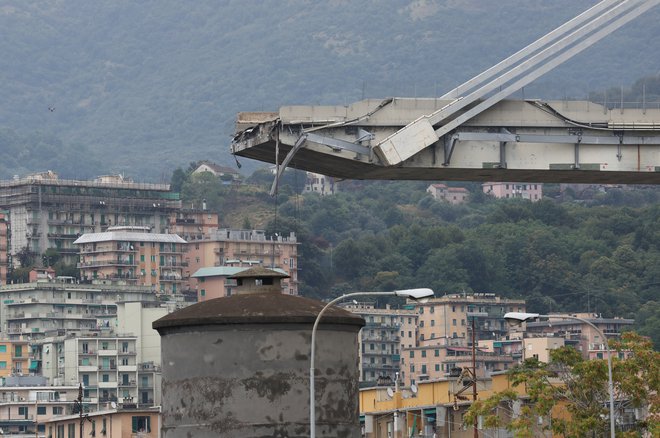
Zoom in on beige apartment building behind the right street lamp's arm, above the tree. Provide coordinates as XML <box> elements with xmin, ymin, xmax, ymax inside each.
<box><xmin>524</xmin><ymin>313</ymin><xmax>635</xmax><ymax>359</ymax></box>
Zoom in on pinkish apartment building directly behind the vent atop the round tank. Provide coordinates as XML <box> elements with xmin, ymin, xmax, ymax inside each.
<box><xmin>186</xmin><ymin>228</ymin><xmax>298</xmax><ymax>296</ymax></box>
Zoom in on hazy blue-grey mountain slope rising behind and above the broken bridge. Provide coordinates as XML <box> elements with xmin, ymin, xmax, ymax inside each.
<box><xmin>0</xmin><ymin>0</ymin><xmax>660</xmax><ymax>181</ymax></box>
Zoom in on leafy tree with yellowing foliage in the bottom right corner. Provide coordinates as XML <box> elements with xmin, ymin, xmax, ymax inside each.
<box><xmin>465</xmin><ymin>332</ymin><xmax>660</xmax><ymax>438</ymax></box>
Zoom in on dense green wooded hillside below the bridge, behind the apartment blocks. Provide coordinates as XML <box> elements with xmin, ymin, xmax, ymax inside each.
<box><xmin>173</xmin><ymin>171</ymin><xmax>660</xmax><ymax>348</ymax></box>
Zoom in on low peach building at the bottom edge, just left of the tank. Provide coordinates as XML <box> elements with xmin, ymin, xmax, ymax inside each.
<box><xmin>44</xmin><ymin>403</ymin><xmax>161</xmax><ymax>438</ymax></box>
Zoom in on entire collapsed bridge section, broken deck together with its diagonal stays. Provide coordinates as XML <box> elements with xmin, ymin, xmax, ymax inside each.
<box><xmin>231</xmin><ymin>0</ymin><xmax>660</xmax><ymax>192</ymax></box>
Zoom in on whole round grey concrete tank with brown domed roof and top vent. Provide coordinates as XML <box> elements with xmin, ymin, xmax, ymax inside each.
<box><xmin>153</xmin><ymin>268</ymin><xmax>364</xmax><ymax>438</ymax></box>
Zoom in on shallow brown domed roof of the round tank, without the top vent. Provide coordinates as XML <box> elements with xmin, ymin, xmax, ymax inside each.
<box><xmin>152</xmin><ymin>293</ymin><xmax>364</xmax><ymax>334</ymax></box>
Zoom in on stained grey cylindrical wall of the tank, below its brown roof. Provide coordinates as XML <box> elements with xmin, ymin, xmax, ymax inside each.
<box><xmin>162</xmin><ymin>324</ymin><xmax>360</xmax><ymax>438</ymax></box>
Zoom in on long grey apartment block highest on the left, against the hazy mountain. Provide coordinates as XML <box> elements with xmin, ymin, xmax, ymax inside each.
<box><xmin>0</xmin><ymin>171</ymin><xmax>181</xmax><ymax>265</ymax></box>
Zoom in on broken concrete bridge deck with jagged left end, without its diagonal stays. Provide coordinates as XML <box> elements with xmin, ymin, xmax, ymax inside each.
<box><xmin>231</xmin><ymin>98</ymin><xmax>660</xmax><ymax>184</ymax></box>
